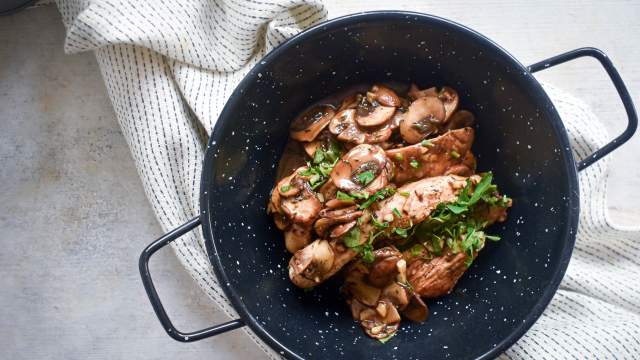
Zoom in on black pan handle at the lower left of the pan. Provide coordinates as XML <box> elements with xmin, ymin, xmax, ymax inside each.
<box><xmin>138</xmin><ymin>217</ymin><xmax>244</xmax><ymax>342</ymax></box>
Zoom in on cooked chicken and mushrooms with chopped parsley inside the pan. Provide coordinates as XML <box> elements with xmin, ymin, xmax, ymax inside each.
<box><xmin>268</xmin><ymin>84</ymin><xmax>512</xmax><ymax>341</ymax></box>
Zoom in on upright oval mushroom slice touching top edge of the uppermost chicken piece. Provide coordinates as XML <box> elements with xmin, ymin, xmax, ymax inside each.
<box><xmin>400</xmin><ymin>97</ymin><xmax>445</xmax><ymax>144</ymax></box>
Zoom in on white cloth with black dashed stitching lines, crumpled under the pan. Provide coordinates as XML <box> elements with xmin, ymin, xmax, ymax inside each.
<box><xmin>57</xmin><ymin>0</ymin><xmax>640</xmax><ymax>359</ymax></box>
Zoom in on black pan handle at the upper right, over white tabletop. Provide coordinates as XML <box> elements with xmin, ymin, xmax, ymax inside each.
<box><xmin>527</xmin><ymin>47</ymin><xmax>638</xmax><ymax>171</ymax></box>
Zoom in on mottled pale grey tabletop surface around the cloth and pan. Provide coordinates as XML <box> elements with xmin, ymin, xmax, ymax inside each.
<box><xmin>0</xmin><ymin>0</ymin><xmax>640</xmax><ymax>359</ymax></box>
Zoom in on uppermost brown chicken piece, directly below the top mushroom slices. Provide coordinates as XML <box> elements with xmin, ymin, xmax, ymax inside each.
<box><xmin>386</xmin><ymin>127</ymin><xmax>475</xmax><ymax>184</ymax></box>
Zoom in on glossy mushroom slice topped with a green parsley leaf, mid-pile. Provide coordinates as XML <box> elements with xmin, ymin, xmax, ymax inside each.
<box><xmin>329</xmin><ymin>144</ymin><xmax>393</xmax><ymax>195</ymax></box>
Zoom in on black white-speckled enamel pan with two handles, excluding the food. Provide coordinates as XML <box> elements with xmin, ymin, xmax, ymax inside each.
<box><xmin>140</xmin><ymin>11</ymin><xmax>637</xmax><ymax>360</ymax></box>
